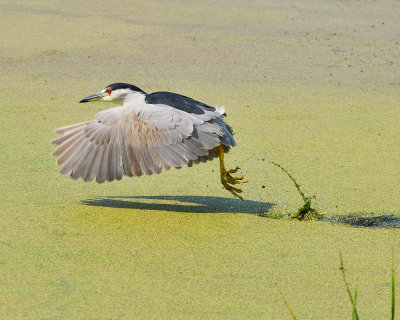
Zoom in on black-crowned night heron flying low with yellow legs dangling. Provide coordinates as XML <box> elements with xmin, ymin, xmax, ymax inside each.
<box><xmin>52</xmin><ymin>83</ymin><xmax>246</xmax><ymax>199</ymax></box>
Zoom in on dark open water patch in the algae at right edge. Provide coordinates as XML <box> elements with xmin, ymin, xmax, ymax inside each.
<box><xmin>319</xmin><ymin>213</ymin><xmax>400</xmax><ymax>229</ymax></box>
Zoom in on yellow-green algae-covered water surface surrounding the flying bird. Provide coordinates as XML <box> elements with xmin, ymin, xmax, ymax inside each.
<box><xmin>0</xmin><ymin>0</ymin><xmax>400</xmax><ymax>319</ymax></box>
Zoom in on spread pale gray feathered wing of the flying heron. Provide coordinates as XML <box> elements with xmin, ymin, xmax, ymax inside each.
<box><xmin>52</xmin><ymin>105</ymin><xmax>235</xmax><ymax>183</ymax></box>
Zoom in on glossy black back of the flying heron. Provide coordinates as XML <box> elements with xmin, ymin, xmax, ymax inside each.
<box><xmin>146</xmin><ymin>91</ymin><xmax>215</xmax><ymax>114</ymax></box>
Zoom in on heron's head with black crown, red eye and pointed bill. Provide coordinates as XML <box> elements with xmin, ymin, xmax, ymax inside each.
<box><xmin>79</xmin><ymin>82</ymin><xmax>146</xmax><ymax>103</ymax></box>
